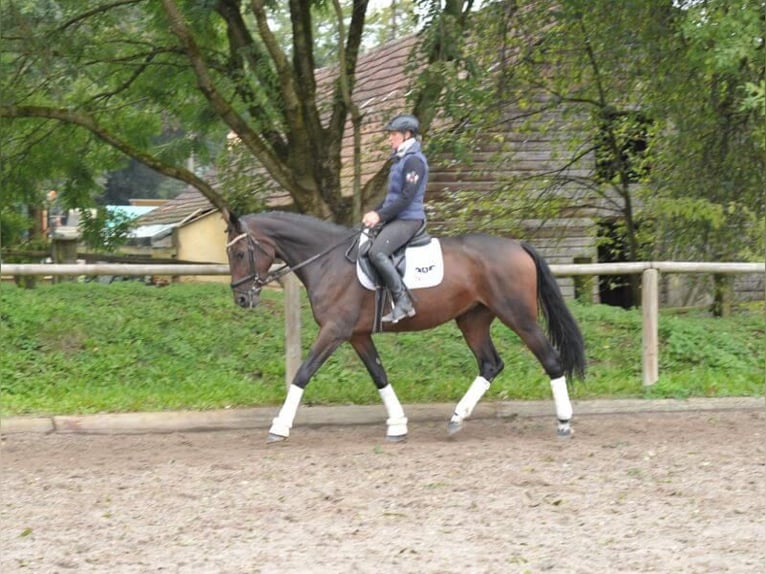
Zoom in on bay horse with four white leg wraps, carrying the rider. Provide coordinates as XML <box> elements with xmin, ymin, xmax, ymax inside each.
<box><xmin>224</xmin><ymin>212</ymin><xmax>585</xmax><ymax>442</ymax></box>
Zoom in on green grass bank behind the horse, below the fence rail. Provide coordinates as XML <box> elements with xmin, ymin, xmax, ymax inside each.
<box><xmin>0</xmin><ymin>282</ymin><xmax>766</xmax><ymax>415</ymax></box>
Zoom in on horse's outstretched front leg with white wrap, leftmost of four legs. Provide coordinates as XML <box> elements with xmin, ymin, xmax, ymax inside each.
<box><xmin>268</xmin><ymin>327</ymin><xmax>345</xmax><ymax>442</ymax></box>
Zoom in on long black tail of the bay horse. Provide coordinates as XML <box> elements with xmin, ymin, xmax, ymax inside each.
<box><xmin>521</xmin><ymin>242</ymin><xmax>585</xmax><ymax>379</ymax></box>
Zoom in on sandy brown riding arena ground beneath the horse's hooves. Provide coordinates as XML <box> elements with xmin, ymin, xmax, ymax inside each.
<box><xmin>0</xmin><ymin>411</ymin><xmax>766</xmax><ymax>574</ymax></box>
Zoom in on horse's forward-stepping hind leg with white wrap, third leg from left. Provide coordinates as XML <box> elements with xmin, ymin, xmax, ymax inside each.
<box><xmin>447</xmin><ymin>306</ymin><xmax>503</xmax><ymax>435</ymax></box>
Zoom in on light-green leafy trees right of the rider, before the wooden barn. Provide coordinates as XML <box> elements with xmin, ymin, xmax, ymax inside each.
<box><xmin>428</xmin><ymin>0</ymin><xmax>766</xmax><ymax>310</ymax></box>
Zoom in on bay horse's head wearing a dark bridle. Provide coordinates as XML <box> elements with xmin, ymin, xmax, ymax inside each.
<box><xmin>226</xmin><ymin>215</ymin><xmax>275</xmax><ymax>309</ymax></box>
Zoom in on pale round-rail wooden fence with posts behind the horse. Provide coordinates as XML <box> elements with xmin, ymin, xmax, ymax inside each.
<box><xmin>0</xmin><ymin>261</ymin><xmax>766</xmax><ymax>385</ymax></box>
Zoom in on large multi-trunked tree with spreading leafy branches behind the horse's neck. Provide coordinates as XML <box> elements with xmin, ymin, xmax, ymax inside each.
<box><xmin>0</xmin><ymin>0</ymin><xmax>480</xmax><ymax>234</ymax></box>
